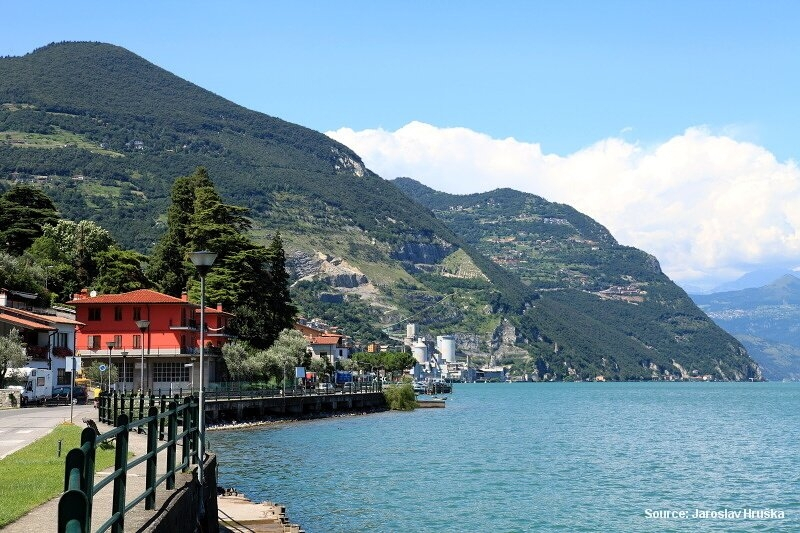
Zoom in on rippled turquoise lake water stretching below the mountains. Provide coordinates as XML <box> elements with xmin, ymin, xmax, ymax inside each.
<box><xmin>209</xmin><ymin>383</ymin><xmax>800</xmax><ymax>533</ymax></box>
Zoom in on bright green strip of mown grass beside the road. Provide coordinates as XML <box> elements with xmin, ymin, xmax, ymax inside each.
<box><xmin>0</xmin><ymin>424</ymin><xmax>114</xmax><ymax>529</ymax></box>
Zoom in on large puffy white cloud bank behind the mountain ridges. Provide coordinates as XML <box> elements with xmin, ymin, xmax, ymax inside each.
<box><xmin>328</xmin><ymin>122</ymin><xmax>800</xmax><ymax>287</ymax></box>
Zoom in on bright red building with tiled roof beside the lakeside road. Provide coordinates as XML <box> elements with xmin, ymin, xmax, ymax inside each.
<box><xmin>67</xmin><ymin>289</ymin><xmax>234</xmax><ymax>393</ymax></box>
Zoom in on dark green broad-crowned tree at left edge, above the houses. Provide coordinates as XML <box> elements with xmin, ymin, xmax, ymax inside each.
<box><xmin>0</xmin><ymin>185</ymin><xmax>58</xmax><ymax>255</ymax></box>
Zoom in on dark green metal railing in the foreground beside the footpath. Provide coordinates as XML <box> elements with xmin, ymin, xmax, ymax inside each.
<box><xmin>58</xmin><ymin>395</ymin><xmax>198</xmax><ymax>533</ymax></box>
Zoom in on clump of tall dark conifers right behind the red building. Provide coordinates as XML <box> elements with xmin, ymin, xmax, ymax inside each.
<box><xmin>148</xmin><ymin>167</ymin><xmax>296</xmax><ymax>350</ymax></box>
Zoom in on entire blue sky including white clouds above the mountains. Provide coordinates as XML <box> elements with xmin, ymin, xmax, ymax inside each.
<box><xmin>0</xmin><ymin>0</ymin><xmax>800</xmax><ymax>292</ymax></box>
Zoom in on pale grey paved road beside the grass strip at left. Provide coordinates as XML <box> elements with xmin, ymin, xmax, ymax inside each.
<box><xmin>0</xmin><ymin>403</ymin><xmax>97</xmax><ymax>459</ymax></box>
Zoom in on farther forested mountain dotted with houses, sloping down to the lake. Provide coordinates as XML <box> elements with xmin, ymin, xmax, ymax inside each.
<box><xmin>393</xmin><ymin>178</ymin><xmax>754</xmax><ymax>379</ymax></box>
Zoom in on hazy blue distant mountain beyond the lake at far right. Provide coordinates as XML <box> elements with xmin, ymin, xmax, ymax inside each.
<box><xmin>692</xmin><ymin>274</ymin><xmax>800</xmax><ymax>380</ymax></box>
